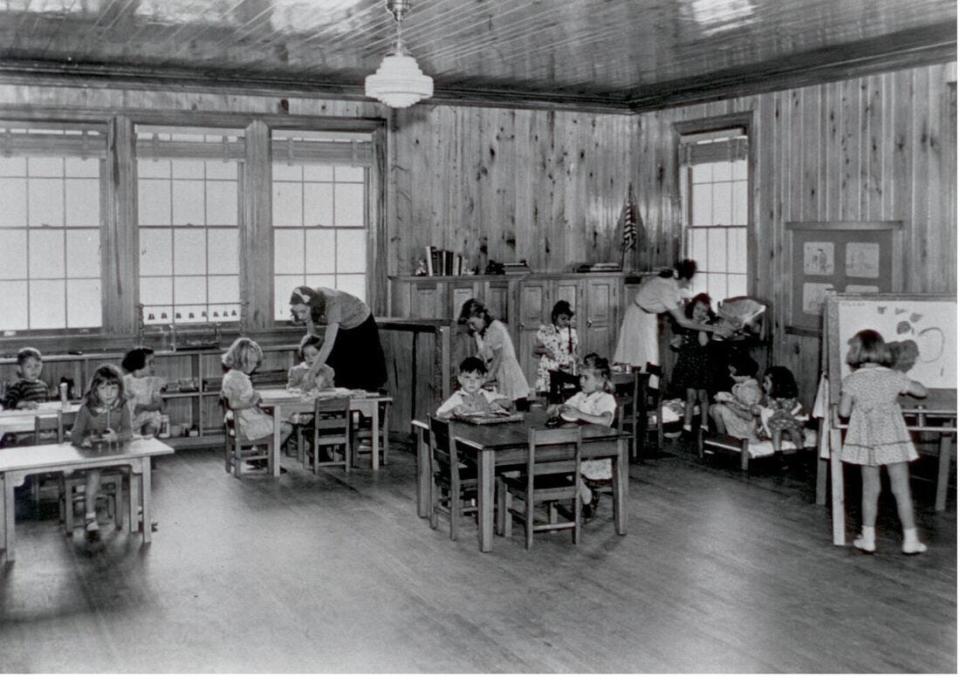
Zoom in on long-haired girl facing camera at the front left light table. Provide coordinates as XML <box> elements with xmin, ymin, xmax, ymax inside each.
<box><xmin>68</xmin><ymin>363</ymin><xmax>133</xmax><ymax>541</ymax></box>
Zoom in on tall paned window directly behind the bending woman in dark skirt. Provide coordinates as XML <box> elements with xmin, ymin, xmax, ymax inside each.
<box><xmin>272</xmin><ymin>131</ymin><xmax>372</xmax><ymax>320</ymax></box>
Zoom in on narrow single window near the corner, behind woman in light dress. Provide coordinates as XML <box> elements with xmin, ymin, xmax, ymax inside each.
<box><xmin>680</xmin><ymin>128</ymin><xmax>749</xmax><ymax>301</ymax></box>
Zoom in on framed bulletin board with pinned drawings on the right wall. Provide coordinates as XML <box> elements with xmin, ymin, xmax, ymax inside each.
<box><xmin>786</xmin><ymin>221</ymin><xmax>902</xmax><ymax>335</ymax></box>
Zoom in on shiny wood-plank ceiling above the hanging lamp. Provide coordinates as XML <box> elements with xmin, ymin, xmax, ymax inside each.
<box><xmin>0</xmin><ymin>0</ymin><xmax>957</xmax><ymax>110</ymax></box>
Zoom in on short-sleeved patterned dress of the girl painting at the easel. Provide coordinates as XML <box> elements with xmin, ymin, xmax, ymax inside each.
<box><xmin>840</xmin><ymin>367</ymin><xmax>919</xmax><ymax>465</ymax></box>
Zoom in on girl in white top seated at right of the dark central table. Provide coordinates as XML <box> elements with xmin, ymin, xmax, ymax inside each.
<box><xmin>547</xmin><ymin>354</ymin><xmax>617</xmax><ymax>520</ymax></box>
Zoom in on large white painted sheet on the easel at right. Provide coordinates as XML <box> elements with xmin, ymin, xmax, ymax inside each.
<box><xmin>823</xmin><ymin>294</ymin><xmax>957</xmax><ymax>405</ymax></box>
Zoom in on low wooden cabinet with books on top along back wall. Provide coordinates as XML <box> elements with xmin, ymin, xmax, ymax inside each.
<box><xmin>390</xmin><ymin>273</ymin><xmax>623</xmax><ymax>396</ymax></box>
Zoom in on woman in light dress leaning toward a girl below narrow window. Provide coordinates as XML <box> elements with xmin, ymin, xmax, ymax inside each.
<box><xmin>613</xmin><ymin>260</ymin><xmax>717</xmax><ymax>368</ymax></box>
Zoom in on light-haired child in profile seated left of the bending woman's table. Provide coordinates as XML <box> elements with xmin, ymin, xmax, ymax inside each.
<box><xmin>220</xmin><ymin>337</ymin><xmax>293</xmax><ymax>444</ymax></box>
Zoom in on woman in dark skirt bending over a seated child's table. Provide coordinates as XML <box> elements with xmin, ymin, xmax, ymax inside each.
<box><xmin>290</xmin><ymin>287</ymin><xmax>387</xmax><ymax>391</ymax></box>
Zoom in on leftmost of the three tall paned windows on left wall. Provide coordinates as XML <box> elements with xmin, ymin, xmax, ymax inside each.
<box><xmin>0</xmin><ymin>128</ymin><xmax>106</xmax><ymax>331</ymax></box>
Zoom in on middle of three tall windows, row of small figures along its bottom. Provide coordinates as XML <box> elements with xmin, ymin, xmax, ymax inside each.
<box><xmin>137</xmin><ymin>126</ymin><xmax>244</xmax><ymax>325</ymax></box>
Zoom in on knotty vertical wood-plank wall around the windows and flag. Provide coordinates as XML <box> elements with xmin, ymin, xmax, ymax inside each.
<box><xmin>0</xmin><ymin>63</ymin><xmax>957</xmax><ymax>406</ymax></box>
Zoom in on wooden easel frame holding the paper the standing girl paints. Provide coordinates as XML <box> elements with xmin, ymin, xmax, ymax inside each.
<box><xmin>817</xmin><ymin>294</ymin><xmax>957</xmax><ymax>545</ymax></box>
